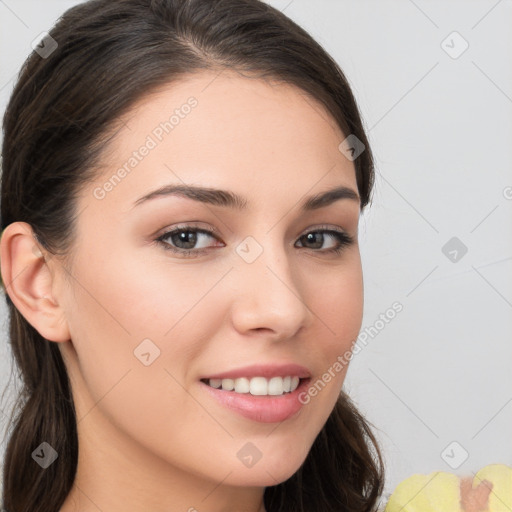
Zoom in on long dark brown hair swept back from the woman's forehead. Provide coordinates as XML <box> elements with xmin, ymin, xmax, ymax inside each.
<box><xmin>1</xmin><ymin>0</ymin><xmax>384</xmax><ymax>512</ymax></box>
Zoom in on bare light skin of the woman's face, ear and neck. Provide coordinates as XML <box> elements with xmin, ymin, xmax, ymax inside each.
<box><xmin>1</xmin><ymin>71</ymin><xmax>363</xmax><ymax>512</ymax></box>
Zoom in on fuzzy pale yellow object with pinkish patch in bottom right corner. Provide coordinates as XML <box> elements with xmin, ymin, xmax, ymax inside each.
<box><xmin>384</xmin><ymin>464</ymin><xmax>512</xmax><ymax>512</ymax></box>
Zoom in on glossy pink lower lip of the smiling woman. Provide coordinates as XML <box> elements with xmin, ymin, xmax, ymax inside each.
<box><xmin>199</xmin><ymin>379</ymin><xmax>310</xmax><ymax>423</ymax></box>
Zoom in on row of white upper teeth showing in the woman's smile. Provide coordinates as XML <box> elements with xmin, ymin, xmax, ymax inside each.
<box><xmin>207</xmin><ymin>375</ymin><xmax>300</xmax><ymax>396</ymax></box>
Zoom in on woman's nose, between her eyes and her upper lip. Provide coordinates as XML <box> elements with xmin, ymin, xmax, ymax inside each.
<box><xmin>231</xmin><ymin>242</ymin><xmax>313</xmax><ymax>341</ymax></box>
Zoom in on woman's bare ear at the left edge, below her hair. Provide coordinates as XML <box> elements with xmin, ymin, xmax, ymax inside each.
<box><xmin>0</xmin><ymin>222</ymin><xmax>70</xmax><ymax>342</ymax></box>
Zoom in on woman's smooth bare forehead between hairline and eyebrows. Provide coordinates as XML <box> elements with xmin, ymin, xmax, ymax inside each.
<box><xmin>86</xmin><ymin>71</ymin><xmax>357</xmax><ymax>212</ymax></box>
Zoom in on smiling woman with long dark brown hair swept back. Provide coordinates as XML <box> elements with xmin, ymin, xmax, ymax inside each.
<box><xmin>1</xmin><ymin>0</ymin><xmax>384</xmax><ymax>512</ymax></box>
